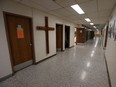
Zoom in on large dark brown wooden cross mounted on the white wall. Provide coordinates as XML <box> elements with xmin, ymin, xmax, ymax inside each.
<box><xmin>37</xmin><ymin>17</ymin><xmax>54</xmax><ymax>54</ymax></box>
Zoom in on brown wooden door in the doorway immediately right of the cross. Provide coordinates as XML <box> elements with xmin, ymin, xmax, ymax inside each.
<box><xmin>56</xmin><ymin>24</ymin><xmax>63</xmax><ymax>51</ymax></box>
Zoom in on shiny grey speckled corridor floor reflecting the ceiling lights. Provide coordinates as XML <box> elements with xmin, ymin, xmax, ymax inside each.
<box><xmin>0</xmin><ymin>38</ymin><xmax>109</xmax><ymax>87</ymax></box>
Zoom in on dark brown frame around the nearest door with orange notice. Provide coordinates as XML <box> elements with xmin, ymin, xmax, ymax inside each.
<box><xmin>3</xmin><ymin>11</ymin><xmax>35</xmax><ymax>74</ymax></box>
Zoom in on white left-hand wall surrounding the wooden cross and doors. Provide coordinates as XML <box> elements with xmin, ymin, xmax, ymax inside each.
<box><xmin>0</xmin><ymin>0</ymin><xmax>75</xmax><ymax>78</ymax></box>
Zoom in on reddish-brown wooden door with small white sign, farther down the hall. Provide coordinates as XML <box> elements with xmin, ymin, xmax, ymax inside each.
<box><xmin>76</xmin><ymin>28</ymin><xmax>85</xmax><ymax>43</ymax></box>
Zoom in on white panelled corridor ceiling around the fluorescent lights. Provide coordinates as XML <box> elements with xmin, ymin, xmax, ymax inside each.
<box><xmin>16</xmin><ymin>0</ymin><xmax>116</xmax><ymax>28</ymax></box>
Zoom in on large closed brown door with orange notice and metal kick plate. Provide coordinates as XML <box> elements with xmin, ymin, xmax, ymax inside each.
<box><xmin>4</xmin><ymin>12</ymin><xmax>34</xmax><ymax>72</ymax></box>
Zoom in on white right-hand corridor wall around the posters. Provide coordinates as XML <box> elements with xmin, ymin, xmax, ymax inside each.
<box><xmin>105</xmin><ymin>7</ymin><xmax>116</xmax><ymax>87</ymax></box>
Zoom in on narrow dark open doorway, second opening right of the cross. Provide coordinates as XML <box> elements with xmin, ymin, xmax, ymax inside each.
<box><xmin>65</xmin><ymin>26</ymin><xmax>70</xmax><ymax>48</ymax></box>
